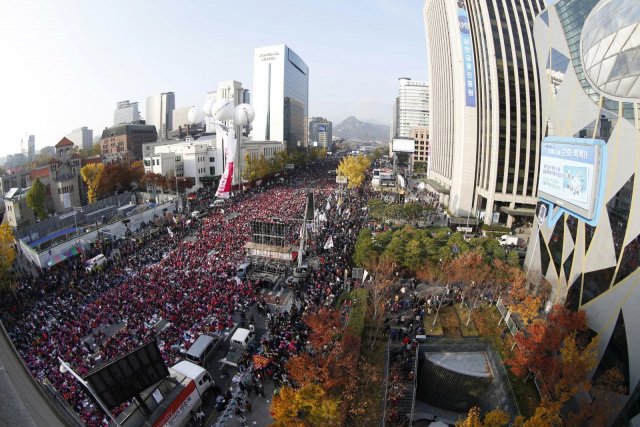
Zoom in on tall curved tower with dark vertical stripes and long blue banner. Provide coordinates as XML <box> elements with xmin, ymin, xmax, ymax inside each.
<box><xmin>424</xmin><ymin>0</ymin><xmax>544</xmax><ymax>226</ymax></box>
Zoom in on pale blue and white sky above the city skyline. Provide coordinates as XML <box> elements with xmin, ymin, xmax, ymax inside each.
<box><xmin>0</xmin><ymin>0</ymin><xmax>428</xmax><ymax>156</ymax></box>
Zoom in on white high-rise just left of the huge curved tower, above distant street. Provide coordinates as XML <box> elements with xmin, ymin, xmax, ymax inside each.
<box><xmin>392</xmin><ymin>77</ymin><xmax>429</xmax><ymax>139</ymax></box>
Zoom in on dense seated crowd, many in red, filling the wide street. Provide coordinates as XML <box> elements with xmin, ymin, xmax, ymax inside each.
<box><xmin>2</xmin><ymin>161</ymin><xmax>355</xmax><ymax>426</ymax></box>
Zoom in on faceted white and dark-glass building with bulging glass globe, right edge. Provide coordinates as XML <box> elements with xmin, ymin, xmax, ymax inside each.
<box><xmin>525</xmin><ymin>0</ymin><xmax>640</xmax><ymax>426</ymax></box>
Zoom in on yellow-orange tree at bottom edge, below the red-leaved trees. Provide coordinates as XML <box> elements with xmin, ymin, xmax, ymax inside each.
<box><xmin>271</xmin><ymin>384</ymin><xmax>340</xmax><ymax>427</ymax></box>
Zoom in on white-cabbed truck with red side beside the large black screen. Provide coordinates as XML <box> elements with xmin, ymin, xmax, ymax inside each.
<box><xmin>117</xmin><ymin>360</ymin><xmax>213</xmax><ymax>427</ymax></box>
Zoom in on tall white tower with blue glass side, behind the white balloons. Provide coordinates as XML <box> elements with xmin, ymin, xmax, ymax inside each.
<box><xmin>252</xmin><ymin>44</ymin><xmax>309</xmax><ymax>152</ymax></box>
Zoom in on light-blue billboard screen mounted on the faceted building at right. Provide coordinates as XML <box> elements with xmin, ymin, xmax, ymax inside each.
<box><xmin>538</xmin><ymin>138</ymin><xmax>606</xmax><ymax>220</ymax></box>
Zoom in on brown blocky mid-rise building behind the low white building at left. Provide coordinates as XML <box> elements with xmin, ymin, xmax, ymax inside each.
<box><xmin>100</xmin><ymin>124</ymin><xmax>158</xmax><ymax>160</ymax></box>
